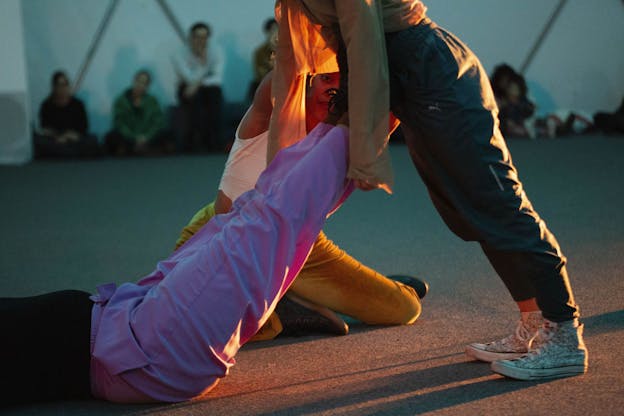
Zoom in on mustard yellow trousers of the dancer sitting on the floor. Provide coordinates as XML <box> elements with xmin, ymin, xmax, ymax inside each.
<box><xmin>176</xmin><ymin>202</ymin><xmax>421</xmax><ymax>341</ymax></box>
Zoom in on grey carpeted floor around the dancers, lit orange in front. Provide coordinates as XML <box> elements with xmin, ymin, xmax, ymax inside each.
<box><xmin>0</xmin><ymin>136</ymin><xmax>624</xmax><ymax>416</ymax></box>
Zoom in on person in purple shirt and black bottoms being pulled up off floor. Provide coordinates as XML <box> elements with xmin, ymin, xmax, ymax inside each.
<box><xmin>0</xmin><ymin>109</ymin><xmax>352</xmax><ymax>404</ymax></box>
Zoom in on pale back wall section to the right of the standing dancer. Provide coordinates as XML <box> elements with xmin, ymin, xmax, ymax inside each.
<box><xmin>425</xmin><ymin>0</ymin><xmax>624</xmax><ymax>114</ymax></box>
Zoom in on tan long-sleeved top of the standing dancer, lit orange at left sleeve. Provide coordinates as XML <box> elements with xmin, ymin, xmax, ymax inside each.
<box><xmin>269</xmin><ymin>0</ymin><xmax>426</xmax><ymax>192</ymax></box>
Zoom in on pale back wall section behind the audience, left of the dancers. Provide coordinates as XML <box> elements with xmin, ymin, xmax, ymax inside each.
<box><xmin>22</xmin><ymin>0</ymin><xmax>274</xmax><ymax>135</ymax></box>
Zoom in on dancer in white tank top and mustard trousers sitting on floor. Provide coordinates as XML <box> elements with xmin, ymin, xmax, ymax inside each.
<box><xmin>176</xmin><ymin>72</ymin><xmax>427</xmax><ymax>340</ymax></box>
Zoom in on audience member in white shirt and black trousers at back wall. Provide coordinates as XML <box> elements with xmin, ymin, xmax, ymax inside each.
<box><xmin>173</xmin><ymin>22</ymin><xmax>223</xmax><ymax>151</ymax></box>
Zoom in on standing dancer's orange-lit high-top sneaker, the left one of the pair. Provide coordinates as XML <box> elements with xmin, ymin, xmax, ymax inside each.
<box><xmin>466</xmin><ymin>311</ymin><xmax>544</xmax><ymax>362</ymax></box>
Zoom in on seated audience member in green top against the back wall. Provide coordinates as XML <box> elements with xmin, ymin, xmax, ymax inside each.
<box><xmin>106</xmin><ymin>70</ymin><xmax>172</xmax><ymax>155</ymax></box>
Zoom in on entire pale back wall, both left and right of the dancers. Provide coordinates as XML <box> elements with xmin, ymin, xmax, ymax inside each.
<box><xmin>19</xmin><ymin>0</ymin><xmax>624</xmax><ymax>138</ymax></box>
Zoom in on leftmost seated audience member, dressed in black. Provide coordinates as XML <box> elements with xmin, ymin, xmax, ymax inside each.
<box><xmin>34</xmin><ymin>71</ymin><xmax>99</xmax><ymax>157</ymax></box>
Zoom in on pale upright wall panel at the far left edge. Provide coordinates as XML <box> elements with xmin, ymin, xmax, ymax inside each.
<box><xmin>0</xmin><ymin>0</ymin><xmax>31</xmax><ymax>163</ymax></box>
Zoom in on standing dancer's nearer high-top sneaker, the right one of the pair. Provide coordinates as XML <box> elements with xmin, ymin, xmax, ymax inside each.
<box><xmin>492</xmin><ymin>319</ymin><xmax>587</xmax><ymax>380</ymax></box>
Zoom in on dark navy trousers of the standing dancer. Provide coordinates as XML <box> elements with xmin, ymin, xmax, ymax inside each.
<box><xmin>388</xmin><ymin>23</ymin><xmax>578</xmax><ymax>322</ymax></box>
